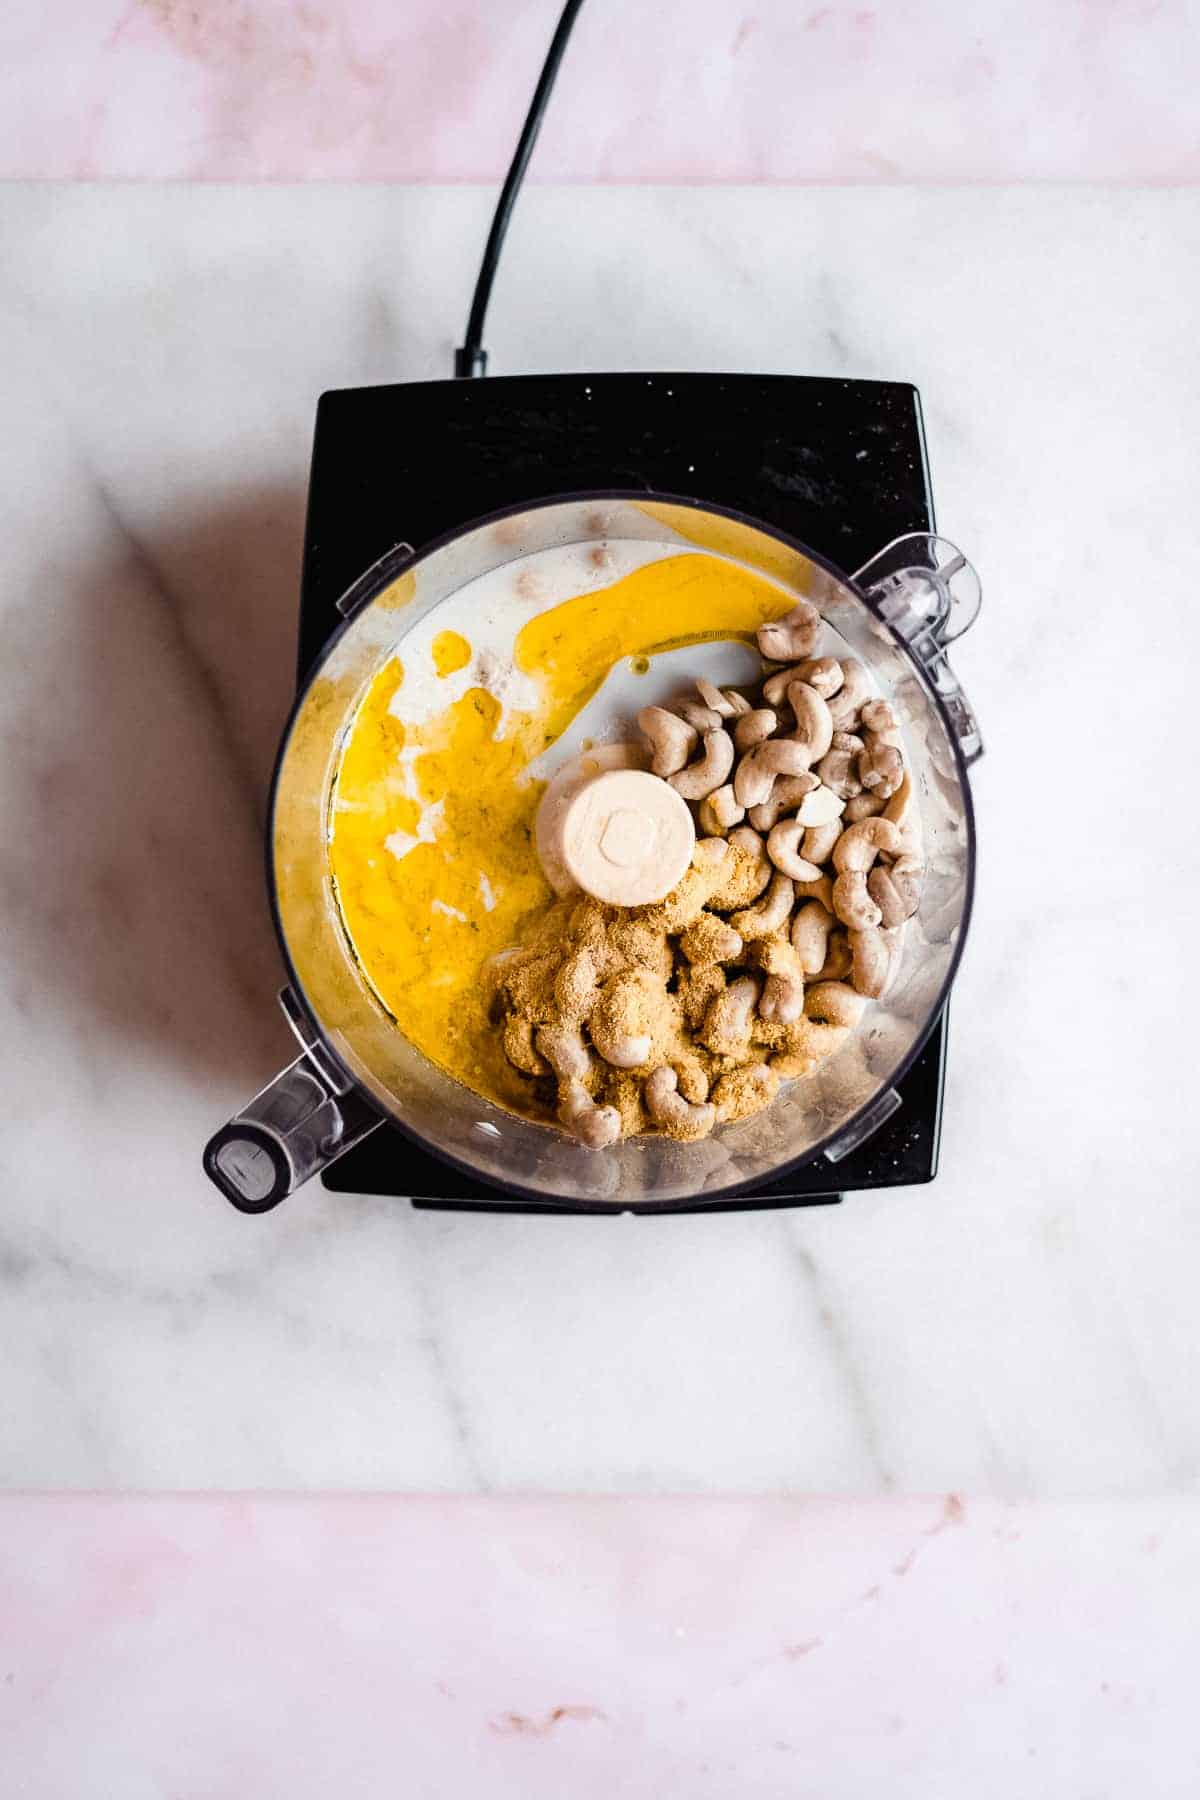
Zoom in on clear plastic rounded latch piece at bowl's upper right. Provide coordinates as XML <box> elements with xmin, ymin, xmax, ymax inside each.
<box><xmin>853</xmin><ymin>531</ymin><xmax>984</xmax><ymax>763</ymax></box>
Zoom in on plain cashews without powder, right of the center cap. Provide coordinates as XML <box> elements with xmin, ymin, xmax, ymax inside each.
<box><xmin>637</xmin><ymin>599</ymin><xmax>925</xmax><ymax>1008</ymax></box>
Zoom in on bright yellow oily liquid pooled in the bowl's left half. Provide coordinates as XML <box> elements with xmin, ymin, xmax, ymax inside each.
<box><xmin>329</xmin><ymin>553</ymin><xmax>795</xmax><ymax>1112</ymax></box>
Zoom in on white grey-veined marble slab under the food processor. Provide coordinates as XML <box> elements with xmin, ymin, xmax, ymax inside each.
<box><xmin>0</xmin><ymin>187</ymin><xmax>1200</xmax><ymax>1496</ymax></box>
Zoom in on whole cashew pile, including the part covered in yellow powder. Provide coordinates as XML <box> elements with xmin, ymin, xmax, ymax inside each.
<box><xmin>489</xmin><ymin>601</ymin><xmax>923</xmax><ymax>1148</ymax></box>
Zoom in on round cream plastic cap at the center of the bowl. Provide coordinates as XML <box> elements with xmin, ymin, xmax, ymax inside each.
<box><xmin>561</xmin><ymin>769</ymin><xmax>696</xmax><ymax>905</ymax></box>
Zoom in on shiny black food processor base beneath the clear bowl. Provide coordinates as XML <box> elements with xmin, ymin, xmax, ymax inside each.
<box><xmin>299</xmin><ymin>374</ymin><xmax>946</xmax><ymax>1213</ymax></box>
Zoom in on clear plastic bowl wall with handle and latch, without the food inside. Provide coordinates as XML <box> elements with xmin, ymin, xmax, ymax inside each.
<box><xmin>205</xmin><ymin>493</ymin><xmax>981</xmax><ymax>1211</ymax></box>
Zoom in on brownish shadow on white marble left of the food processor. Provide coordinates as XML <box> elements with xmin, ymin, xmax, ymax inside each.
<box><xmin>5</xmin><ymin>488</ymin><xmax>304</xmax><ymax>1098</ymax></box>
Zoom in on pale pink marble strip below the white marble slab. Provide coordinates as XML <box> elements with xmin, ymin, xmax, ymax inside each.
<box><xmin>0</xmin><ymin>1496</ymin><xmax>1200</xmax><ymax>1800</ymax></box>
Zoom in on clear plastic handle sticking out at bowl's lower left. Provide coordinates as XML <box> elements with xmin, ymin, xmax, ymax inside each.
<box><xmin>203</xmin><ymin>990</ymin><xmax>383</xmax><ymax>1213</ymax></box>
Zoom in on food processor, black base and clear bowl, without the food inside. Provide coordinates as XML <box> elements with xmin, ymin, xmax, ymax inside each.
<box><xmin>205</xmin><ymin>373</ymin><xmax>981</xmax><ymax>1211</ymax></box>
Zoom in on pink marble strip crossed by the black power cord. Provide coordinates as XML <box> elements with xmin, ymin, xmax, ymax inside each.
<box><xmin>0</xmin><ymin>0</ymin><xmax>1200</xmax><ymax>182</ymax></box>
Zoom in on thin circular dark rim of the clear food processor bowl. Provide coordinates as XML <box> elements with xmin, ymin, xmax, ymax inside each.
<box><xmin>263</xmin><ymin>488</ymin><xmax>975</xmax><ymax>1217</ymax></box>
